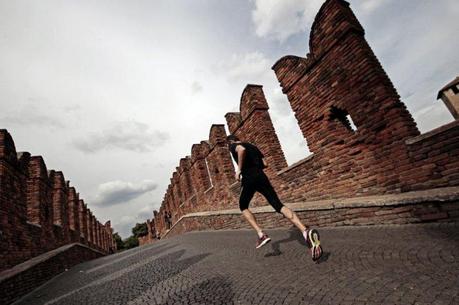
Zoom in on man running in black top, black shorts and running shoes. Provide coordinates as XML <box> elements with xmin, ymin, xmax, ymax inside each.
<box><xmin>226</xmin><ymin>135</ymin><xmax>322</xmax><ymax>261</ymax></box>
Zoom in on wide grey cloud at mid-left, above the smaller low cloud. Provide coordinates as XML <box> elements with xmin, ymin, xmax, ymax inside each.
<box><xmin>74</xmin><ymin>121</ymin><xmax>169</xmax><ymax>153</ymax></box>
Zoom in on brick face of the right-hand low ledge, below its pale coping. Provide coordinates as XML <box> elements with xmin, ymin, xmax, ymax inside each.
<box><xmin>167</xmin><ymin>200</ymin><xmax>459</xmax><ymax>237</ymax></box>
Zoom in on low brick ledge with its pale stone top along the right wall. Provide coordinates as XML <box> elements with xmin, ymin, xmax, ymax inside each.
<box><xmin>163</xmin><ymin>187</ymin><xmax>459</xmax><ymax>238</ymax></box>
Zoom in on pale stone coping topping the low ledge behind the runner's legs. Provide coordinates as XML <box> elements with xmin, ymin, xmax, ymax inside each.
<box><xmin>163</xmin><ymin>186</ymin><xmax>459</xmax><ymax>238</ymax></box>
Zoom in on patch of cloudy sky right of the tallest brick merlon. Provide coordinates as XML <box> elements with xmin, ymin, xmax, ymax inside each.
<box><xmin>353</xmin><ymin>0</ymin><xmax>459</xmax><ymax>132</ymax></box>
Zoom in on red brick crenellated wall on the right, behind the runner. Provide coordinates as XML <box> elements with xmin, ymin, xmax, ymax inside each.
<box><xmin>145</xmin><ymin>0</ymin><xmax>459</xmax><ymax>236</ymax></box>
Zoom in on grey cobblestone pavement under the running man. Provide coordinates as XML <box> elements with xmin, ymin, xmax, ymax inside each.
<box><xmin>17</xmin><ymin>224</ymin><xmax>459</xmax><ymax>305</ymax></box>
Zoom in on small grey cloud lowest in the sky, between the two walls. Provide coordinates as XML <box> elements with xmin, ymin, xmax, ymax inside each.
<box><xmin>93</xmin><ymin>180</ymin><xmax>157</xmax><ymax>206</ymax></box>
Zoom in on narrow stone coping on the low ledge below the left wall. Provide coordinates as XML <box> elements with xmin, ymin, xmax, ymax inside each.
<box><xmin>0</xmin><ymin>243</ymin><xmax>105</xmax><ymax>282</ymax></box>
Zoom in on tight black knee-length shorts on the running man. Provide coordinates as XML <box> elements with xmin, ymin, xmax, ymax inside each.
<box><xmin>239</xmin><ymin>170</ymin><xmax>284</xmax><ymax>213</ymax></box>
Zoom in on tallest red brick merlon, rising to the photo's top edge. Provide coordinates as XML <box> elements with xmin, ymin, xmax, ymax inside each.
<box><xmin>273</xmin><ymin>0</ymin><xmax>419</xmax><ymax>153</ymax></box>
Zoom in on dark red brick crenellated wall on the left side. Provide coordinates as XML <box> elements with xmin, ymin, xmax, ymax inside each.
<box><xmin>0</xmin><ymin>129</ymin><xmax>116</xmax><ymax>271</ymax></box>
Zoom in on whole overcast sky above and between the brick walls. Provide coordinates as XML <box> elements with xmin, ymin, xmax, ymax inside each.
<box><xmin>0</xmin><ymin>0</ymin><xmax>459</xmax><ymax>237</ymax></box>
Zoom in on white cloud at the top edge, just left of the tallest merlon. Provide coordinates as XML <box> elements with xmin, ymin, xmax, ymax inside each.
<box><xmin>252</xmin><ymin>0</ymin><xmax>324</xmax><ymax>42</ymax></box>
